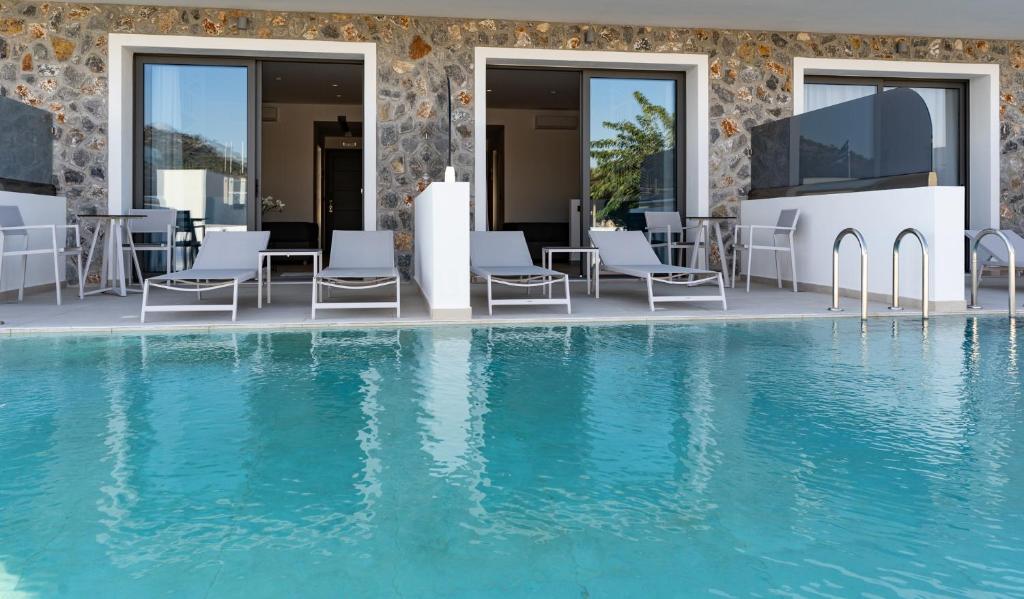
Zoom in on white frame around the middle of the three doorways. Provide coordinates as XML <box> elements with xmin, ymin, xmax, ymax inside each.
<box><xmin>473</xmin><ymin>46</ymin><xmax>711</xmax><ymax>230</ymax></box>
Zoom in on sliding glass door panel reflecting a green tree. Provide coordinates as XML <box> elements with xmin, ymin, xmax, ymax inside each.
<box><xmin>581</xmin><ymin>72</ymin><xmax>685</xmax><ymax>233</ymax></box>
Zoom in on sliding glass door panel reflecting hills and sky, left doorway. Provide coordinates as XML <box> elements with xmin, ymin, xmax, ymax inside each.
<box><xmin>133</xmin><ymin>56</ymin><xmax>258</xmax><ymax>230</ymax></box>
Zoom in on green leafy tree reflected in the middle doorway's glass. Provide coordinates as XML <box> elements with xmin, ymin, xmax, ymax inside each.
<box><xmin>590</xmin><ymin>91</ymin><xmax>676</xmax><ymax>222</ymax></box>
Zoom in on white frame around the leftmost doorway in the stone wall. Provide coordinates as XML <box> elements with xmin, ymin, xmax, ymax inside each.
<box><xmin>108</xmin><ymin>34</ymin><xmax>377</xmax><ymax>230</ymax></box>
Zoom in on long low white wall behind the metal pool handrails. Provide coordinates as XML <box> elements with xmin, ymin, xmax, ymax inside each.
<box><xmin>737</xmin><ymin>187</ymin><xmax>966</xmax><ymax>312</ymax></box>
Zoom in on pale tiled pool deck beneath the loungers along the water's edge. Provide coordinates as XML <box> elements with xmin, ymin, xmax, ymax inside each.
<box><xmin>0</xmin><ymin>280</ymin><xmax>1007</xmax><ymax>335</ymax></box>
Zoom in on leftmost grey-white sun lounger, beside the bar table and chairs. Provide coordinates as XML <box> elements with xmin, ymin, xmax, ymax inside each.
<box><xmin>141</xmin><ymin>230</ymin><xmax>270</xmax><ymax>323</ymax></box>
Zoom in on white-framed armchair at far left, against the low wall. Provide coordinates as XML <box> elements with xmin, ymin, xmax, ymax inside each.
<box><xmin>0</xmin><ymin>206</ymin><xmax>85</xmax><ymax>306</ymax></box>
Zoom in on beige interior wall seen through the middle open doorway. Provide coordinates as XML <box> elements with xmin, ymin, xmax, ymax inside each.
<box><xmin>487</xmin><ymin>109</ymin><xmax>583</xmax><ymax>222</ymax></box>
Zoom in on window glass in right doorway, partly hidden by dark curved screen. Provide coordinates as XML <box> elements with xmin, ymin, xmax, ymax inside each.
<box><xmin>804</xmin><ymin>77</ymin><xmax>968</xmax><ymax>187</ymax></box>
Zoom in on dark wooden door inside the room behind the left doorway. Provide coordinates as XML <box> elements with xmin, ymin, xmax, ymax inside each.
<box><xmin>323</xmin><ymin>149</ymin><xmax>362</xmax><ymax>255</ymax></box>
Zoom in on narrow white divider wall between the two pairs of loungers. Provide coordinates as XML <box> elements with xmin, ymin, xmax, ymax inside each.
<box><xmin>414</xmin><ymin>182</ymin><xmax>472</xmax><ymax>320</ymax></box>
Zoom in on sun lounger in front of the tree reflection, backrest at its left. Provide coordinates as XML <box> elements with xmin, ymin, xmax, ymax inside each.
<box><xmin>590</xmin><ymin>230</ymin><xmax>728</xmax><ymax>311</ymax></box>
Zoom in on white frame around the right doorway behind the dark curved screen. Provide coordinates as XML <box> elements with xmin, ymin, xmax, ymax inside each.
<box><xmin>793</xmin><ymin>57</ymin><xmax>999</xmax><ymax>228</ymax></box>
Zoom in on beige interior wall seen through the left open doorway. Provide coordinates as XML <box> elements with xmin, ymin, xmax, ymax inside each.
<box><xmin>260</xmin><ymin>103</ymin><xmax>362</xmax><ymax>222</ymax></box>
